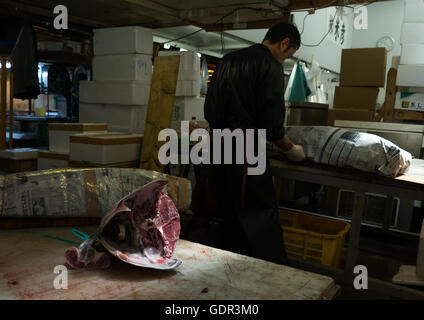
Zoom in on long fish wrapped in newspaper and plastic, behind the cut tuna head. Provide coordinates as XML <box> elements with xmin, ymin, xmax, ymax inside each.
<box><xmin>0</xmin><ymin>168</ymin><xmax>191</xmax><ymax>218</ymax></box>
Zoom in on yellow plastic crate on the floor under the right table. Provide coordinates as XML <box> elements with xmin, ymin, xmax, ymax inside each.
<box><xmin>279</xmin><ymin>209</ymin><xmax>350</xmax><ymax>268</ymax></box>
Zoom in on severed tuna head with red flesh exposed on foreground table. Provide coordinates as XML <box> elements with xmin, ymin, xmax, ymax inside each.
<box><xmin>99</xmin><ymin>180</ymin><xmax>181</xmax><ymax>269</ymax></box>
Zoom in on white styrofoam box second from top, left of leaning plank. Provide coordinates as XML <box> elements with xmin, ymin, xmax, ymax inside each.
<box><xmin>93</xmin><ymin>54</ymin><xmax>152</xmax><ymax>81</ymax></box>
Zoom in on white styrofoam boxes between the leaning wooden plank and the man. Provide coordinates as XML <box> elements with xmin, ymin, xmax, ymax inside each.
<box><xmin>159</xmin><ymin>51</ymin><xmax>205</xmax><ymax>132</ymax></box>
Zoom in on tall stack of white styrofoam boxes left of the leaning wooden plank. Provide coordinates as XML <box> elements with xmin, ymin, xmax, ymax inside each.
<box><xmin>79</xmin><ymin>27</ymin><xmax>153</xmax><ymax>133</ymax></box>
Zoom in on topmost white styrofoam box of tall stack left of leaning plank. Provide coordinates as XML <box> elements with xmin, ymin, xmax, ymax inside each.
<box><xmin>93</xmin><ymin>26</ymin><xmax>153</xmax><ymax>56</ymax></box>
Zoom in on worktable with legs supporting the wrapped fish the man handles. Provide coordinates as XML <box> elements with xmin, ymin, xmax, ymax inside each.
<box><xmin>270</xmin><ymin>155</ymin><xmax>424</xmax><ymax>277</ymax></box>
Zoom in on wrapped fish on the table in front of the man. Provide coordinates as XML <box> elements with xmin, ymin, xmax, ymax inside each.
<box><xmin>280</xmin><ymin>126</ymin><xmax>412</xmax><ymax>177</ymax></box>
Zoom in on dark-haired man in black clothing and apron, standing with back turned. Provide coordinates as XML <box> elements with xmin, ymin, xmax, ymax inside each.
<box><xmin>193</xmin><ymin>23</ymin><xmax>305</xmax><ymax>264</ymax></box>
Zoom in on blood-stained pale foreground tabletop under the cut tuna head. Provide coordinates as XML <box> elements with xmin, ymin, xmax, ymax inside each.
<box><xmin>0</xmin><ymin>227</ymin><xmax>337</xmax><ymax>300</ymax></box>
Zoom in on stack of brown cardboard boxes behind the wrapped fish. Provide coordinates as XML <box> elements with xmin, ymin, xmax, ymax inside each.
<box><xmin>328</xmin><ymin>48</ymin><xmax>387</xmax><ymax>126</ymax></box>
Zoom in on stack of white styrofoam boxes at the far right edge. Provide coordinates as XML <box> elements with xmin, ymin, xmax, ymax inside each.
<box><xmin>395</xmin><ymin>0</ymin><xmax>424</xmax><ymax>111</ymax></box>
